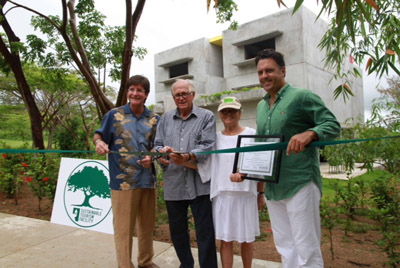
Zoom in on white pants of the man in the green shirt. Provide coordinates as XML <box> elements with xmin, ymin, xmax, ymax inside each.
<box><xmin>267</xmin><ymin>183</ymin><xmax>324</xmax><ymax>268</ymax></box>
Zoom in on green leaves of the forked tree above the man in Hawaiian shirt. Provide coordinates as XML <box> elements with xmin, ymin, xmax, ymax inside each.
<box><xmin>28</xmin><ymin>0</ymin><xmax>147</xmax><ymax>84</ymax></box>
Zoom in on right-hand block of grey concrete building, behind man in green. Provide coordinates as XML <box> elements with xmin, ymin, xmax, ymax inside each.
<box><xmin>223</xmin><ymin>7</ymin><xmax>364</xmax><ymax>123</ymax></box>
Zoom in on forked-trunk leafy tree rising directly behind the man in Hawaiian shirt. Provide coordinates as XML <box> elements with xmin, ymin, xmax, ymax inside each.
<box><xmin>0</xmin><ymin>0</ymin><xmax>146</xmax><ymax>115</ymax></box>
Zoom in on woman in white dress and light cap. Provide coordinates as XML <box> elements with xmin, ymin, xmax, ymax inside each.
<box><xmin>210</xmin><ymin>97</ymin><xmax>265</xmax><ymax>268</ymax></box>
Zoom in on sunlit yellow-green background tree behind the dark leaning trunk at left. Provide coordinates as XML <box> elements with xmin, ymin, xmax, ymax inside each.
<box><xmin>0</xmin><ymin>64</ymin><xmax>98</xmax><ymax>150</ymax></box>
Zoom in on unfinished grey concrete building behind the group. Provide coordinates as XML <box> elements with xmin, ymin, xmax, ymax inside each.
<box><xmin>155</xmin><ymin>7</ymin><xmax>364</xmax><ymax>130</ymax></box>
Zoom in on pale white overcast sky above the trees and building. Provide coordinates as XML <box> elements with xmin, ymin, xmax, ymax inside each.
<box><xmin>1</xmin><ymin>0</ymin><xmax>386</xmax><ymax>118</ymax></box>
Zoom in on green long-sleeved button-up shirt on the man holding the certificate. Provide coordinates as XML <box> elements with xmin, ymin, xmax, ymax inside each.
<box><xmin>257</xmin><ymin>84</ymin><xmax>340</xmax><ymax>200</ymax></box>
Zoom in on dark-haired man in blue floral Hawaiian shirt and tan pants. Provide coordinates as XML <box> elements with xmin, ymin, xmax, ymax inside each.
<box><xmin>93</xmin><ymin>75</ymin><xmax>160</xmax><ymax>268</ymax></box>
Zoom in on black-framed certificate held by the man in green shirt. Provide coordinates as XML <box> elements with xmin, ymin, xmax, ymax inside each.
<box><xmin>232</xmin><ymin>135</ymin><xmax>283</xmax><ymax>183</ymax></box>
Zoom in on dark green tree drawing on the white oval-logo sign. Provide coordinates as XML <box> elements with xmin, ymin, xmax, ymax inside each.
<box><xmin>67</xmin><ymin>167</ymin><xmax>110</xmax><ymax>208</ymax></box>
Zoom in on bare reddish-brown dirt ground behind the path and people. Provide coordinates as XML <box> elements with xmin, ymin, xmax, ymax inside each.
<box><xmin>0</xmin><ymin>186</ymin><xmax>388</xmax><ymax>268</ymax></box>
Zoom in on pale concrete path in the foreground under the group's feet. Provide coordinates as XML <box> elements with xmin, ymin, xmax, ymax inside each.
<box><xmin>0</xmin><ymin>213</ymin><xmax>282</xmax><ymax>268</ymax></box>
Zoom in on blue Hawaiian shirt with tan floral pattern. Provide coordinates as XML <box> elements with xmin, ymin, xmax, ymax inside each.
<box><xmin>96</xmin><ymin>103</ymin><xmax>160</xmax><ymax>190</ymax></box>
